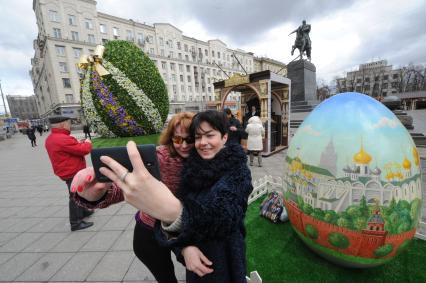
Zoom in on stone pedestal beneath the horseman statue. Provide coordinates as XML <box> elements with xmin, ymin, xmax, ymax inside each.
<box><xmin>287</xmin><ymin>60</ymin><xmax>317</xmax><ymax>103</ymax></box>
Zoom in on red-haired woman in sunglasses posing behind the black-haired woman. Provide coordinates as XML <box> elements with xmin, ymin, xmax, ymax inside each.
<box><xmin>71</xmin><ymin>112</ymin><xmax>194</xmax><ymax>283</ymax></box>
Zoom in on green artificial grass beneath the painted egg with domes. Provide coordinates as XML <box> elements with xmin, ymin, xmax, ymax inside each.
<box><xmin>246</xmin><ymin>199</ymin><xmax>426</xmax><ymax>283</ymax></box>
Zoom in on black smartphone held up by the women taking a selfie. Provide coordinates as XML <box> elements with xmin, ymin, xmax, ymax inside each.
<box><xmin>90</xmin><ymin>144</ymin><xmax>161</xmax><ymax>183</ymax></box>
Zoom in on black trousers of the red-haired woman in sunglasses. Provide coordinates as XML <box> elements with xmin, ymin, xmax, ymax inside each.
<box><xmin>133</xmin><ymin>222</ymin><xmax>177</xmax><ymax>283</ymax></box>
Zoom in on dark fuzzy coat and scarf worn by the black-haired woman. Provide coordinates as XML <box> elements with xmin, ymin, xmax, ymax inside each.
<box><xmin>156</xmin><ymin>144</ymin><xmax>253</xmax><ymax>283</ymax></box>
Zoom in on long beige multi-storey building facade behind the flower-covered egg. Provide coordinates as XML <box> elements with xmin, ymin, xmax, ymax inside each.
<box><xmin>30</xmin><ymin>0</ymin><xmax>285</xmax><ymax>119</ymax></box>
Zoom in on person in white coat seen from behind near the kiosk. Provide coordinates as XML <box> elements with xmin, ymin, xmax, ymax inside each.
<box><xmin>246</xmin><ymin>116</ymin><xmax>265</xmax><ymax>167</ymax></box>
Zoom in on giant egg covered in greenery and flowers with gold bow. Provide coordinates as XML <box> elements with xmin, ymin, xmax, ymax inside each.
<box><xmin>79</xmin><ymin>40</ymin><xmax>169</xmax><ymax>137</ymax></box>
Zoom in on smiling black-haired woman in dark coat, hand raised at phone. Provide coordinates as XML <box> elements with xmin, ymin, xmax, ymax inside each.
<box><xmin>101</xmin><ymin>111</ymin><xmax>253</xmax><ymax>283</ymax></box>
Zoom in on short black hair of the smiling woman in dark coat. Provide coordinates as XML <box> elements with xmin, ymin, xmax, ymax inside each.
<box><xmin>189</xmin><ymin>110</ymin><xmax>229</xmax><ymax>137</ymax></box>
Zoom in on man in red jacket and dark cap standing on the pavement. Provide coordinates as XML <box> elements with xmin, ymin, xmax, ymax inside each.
<box><xmin>45</xmin><ymin>116</ymin><xmax>93</xmax><ymax>231</ymax></box>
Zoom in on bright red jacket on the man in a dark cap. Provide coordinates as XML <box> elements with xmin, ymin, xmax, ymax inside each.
<box><xmin>44</xmin><ymin>128</ymin><xmax>92</xmax><ymax>180</ymax></box>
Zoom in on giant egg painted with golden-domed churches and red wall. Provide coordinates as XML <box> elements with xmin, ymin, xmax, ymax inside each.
<box><xmin>284</xmin><ymin>92</ymin><xmax>422</xmax><ymax>267</ymax></box>
